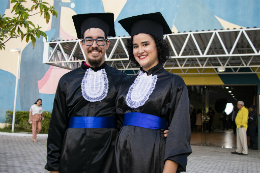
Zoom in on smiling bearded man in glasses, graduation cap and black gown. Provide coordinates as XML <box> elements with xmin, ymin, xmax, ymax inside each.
<box><xmin>45</xmin><ymin>13</ymin><xmax>126</xmax><ymax>173</ymax></box>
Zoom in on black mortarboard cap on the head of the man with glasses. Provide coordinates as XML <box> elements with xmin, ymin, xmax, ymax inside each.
<box><xmin>72</xmin><ymin>13</ymin><xmax>116</xmax><ymax>38</ymax></box>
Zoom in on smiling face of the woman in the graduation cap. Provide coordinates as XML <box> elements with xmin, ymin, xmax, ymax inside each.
<box><xmin>133</xmin><ymin>33</ymin><xmax>159</xmax><ymax>71</ymax></box>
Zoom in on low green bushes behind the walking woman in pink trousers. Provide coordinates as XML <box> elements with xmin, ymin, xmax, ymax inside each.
<box><xmin>5</xmin><ymin>111</ymin><xmax>51</xmax><ymax>133</ymax></box>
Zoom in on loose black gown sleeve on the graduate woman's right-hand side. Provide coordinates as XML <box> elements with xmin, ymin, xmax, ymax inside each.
<box><xmin>165</xmin><ymin>76</ymin><xmax>192</xmax><ymax>171</ymax></box>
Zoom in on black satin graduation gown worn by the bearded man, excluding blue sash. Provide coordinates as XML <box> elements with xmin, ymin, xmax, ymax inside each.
<box><xmin>45</xmin><ymin>63</ymin><xmax>126</xmax><ymax>173</ymax></box>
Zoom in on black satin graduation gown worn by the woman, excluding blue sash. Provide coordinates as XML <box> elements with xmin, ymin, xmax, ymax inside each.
<box><xmin>112</xmin><ymin>64</ymin><xmax>192</xmax><ymax>173</ymax></box>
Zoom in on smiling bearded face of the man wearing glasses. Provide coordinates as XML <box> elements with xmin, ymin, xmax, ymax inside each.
<box><xmin>80</xmin><ymin>28</ymin><xmax>109</xmax><ymax>67</ymax></box>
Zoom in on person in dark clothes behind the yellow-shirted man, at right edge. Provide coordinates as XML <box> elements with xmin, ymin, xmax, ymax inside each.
<box><xmin>248</xmin><ymin>105</ymin><xmax>257</xmax><ymax>150</ymax></box>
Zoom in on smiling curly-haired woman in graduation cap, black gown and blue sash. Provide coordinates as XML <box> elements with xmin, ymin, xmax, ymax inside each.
<box><xmin>112</xmin><ymin>13</ymin><xmax>191</xmax><ymax>173</ymax></box>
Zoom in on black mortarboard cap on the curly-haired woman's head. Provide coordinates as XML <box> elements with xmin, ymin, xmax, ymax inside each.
<box><xmin>118</xmin><ymin>12</ymin><xmax>172</xmax><ymax>37</ymax></box>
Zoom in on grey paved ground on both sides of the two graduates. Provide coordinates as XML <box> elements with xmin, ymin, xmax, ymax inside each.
<box><xmin>0</xmin><ymin>132</ymin><xmax>260</xmax><ymax>173</ymax></box>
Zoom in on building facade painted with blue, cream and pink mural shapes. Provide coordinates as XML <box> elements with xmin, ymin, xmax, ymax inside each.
<box><xmin>0</xmin><ymin>0</ymin><xmax>260</xmax><ymax>147</ymax></box>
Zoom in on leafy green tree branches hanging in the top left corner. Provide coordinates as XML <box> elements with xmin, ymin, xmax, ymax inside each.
<box><xmin>0</xmin><ymin>0</ymin><xmax>58</xmax><ymax>50</ymax></box>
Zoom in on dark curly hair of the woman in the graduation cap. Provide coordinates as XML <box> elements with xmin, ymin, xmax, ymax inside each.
<box><xmin>126</xmin><ymin>34</ymin><xmax>170</xmax><ymax>65</ymax></box>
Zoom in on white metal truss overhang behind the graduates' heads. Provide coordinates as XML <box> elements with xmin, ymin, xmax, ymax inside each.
<box><xmin>43</xmin><ymin>28</ymin><xmax>260</xmax><ymax>74</ymax></box>
